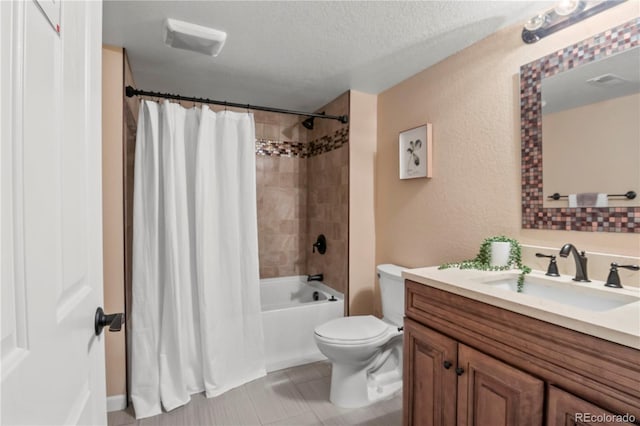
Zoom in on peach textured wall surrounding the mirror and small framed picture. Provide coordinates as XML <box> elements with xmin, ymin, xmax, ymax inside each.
<box><xmin>376</xmin><ymin>1</ymin><xmax>640</xmax><ymax>276</ymax></box>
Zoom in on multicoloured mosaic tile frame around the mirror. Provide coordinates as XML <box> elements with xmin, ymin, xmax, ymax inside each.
<box><xmin>520</xmin><ymin>18</ymin><xmax>640</xmax><ymax>233</ymax></box>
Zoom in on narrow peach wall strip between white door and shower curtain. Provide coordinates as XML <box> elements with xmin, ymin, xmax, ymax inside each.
<box><xmin>102</xmin><ymin>46</ymin><xmax>126</xmax><ymax>396</ymax></box>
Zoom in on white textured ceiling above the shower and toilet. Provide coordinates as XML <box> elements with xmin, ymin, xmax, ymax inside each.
<box><xmin>103</xmin><ymin>0</ymin><xmax>551</xmax><ymax>111</ymax></box>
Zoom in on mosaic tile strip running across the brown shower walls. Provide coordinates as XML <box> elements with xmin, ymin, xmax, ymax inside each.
<box><xmin>256</xmin><ymin>126</ymin><xmax>349</xmax><ymax>158</ymax></box>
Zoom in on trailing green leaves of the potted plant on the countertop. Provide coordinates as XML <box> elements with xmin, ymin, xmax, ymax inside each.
<box><xmin>438</xmin><ymin>235</ymin><xmax>531</xmax><ymax>293</ymax></box>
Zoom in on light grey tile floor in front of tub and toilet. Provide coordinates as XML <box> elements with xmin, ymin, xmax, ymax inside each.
<box><xmin>108</xmin><ymin>362</ymin><xmax>402</xmax><ymax>426</ymax></box>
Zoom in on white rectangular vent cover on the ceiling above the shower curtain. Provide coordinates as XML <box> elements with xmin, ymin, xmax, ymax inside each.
<box><xmin>164</xmin><ymin>18</ymin><xmax>227</xmax><ymax>56</ymax></box>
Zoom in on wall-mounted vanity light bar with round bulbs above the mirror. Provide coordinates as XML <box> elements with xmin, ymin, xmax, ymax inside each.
<box><xmin>522</xmin><ymin>0</ymin><xmax>624</xmax><ymax>43</ymax></box>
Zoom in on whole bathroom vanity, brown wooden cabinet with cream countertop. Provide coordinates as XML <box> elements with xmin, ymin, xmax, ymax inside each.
<box><xmin>403</xmin><ymin>267</ymin><xmax>640</xmax><ymax>426</ymax></box>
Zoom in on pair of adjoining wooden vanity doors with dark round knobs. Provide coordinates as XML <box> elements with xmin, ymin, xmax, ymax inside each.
<box><xmin>404</xmin><ymin>319</ymin><xmax>544</xmax><ymax>426</ymax></box>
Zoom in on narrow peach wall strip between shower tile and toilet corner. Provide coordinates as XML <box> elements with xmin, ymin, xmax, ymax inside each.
<box><xmin>349</xmin><ymin>90</ymin><xmax>381</xmax><ymax>315</ymax></box>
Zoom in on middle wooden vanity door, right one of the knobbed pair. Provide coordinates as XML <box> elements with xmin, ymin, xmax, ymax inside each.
<box><xmin>457</xmin><ymin>344</ymin><xmax>544</xmax><ymax>426</ymax></box>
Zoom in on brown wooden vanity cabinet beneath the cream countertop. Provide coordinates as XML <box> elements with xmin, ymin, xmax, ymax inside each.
<box><xmin>403</xmin><ymin>280</ymin><xmax>640</xmax><ymax>426</ymax></box>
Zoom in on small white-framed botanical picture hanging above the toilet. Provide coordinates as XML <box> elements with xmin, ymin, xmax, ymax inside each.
<box><xmin>398</xmin><ymin>123</ymin><xmax>433</xmax><ymax>179</ymax></box>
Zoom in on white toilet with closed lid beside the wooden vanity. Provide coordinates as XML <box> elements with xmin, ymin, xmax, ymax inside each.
<box><xmin>314</xmin><ymin>264</ymin><xmax>406</xmax><ymax>408</ymax></box>
